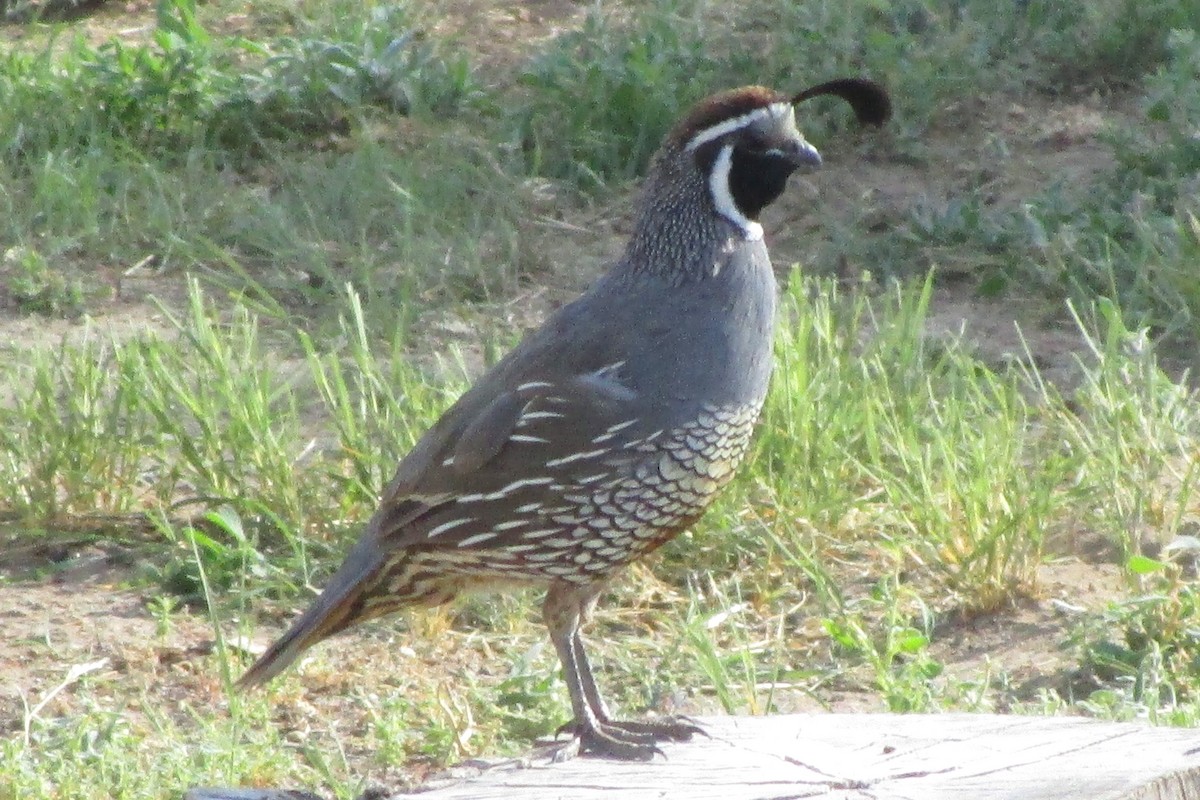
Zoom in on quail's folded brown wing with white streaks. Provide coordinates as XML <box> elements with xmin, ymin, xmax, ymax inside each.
<box><xmin>371</xmin><ymin>362</ymin><xmax>654</xmax><ymax>549</ymax></box>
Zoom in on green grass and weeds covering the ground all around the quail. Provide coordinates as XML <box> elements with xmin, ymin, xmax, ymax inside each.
<box><xmin>7</xmin><ymin>0</ymin><xmax>1200</xmax><ymax>800</ymax></box>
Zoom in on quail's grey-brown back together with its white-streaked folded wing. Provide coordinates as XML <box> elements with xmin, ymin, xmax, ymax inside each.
<box><xmin>367</xmin><ymin>275</ymin><xmax>661</xmax><ymax>549</ymax></box>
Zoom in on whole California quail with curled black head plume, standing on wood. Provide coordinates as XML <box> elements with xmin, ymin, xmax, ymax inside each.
<box><xmin>239</xmin><ymin>79</ymin><xmax>889</xmax><ymax>759</ymax></box>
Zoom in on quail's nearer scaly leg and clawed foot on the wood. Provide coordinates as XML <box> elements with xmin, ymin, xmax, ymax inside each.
<box><xmin>542</xmin><ymin>582</ymin><xmax>662</xmax><ymax>760</ymax></box>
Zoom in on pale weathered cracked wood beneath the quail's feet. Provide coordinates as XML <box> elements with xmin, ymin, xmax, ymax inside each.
<box><xmin>188</xmin><ymin>714</ymin><xmax>1200</xmax><ymax>800</ymax></box>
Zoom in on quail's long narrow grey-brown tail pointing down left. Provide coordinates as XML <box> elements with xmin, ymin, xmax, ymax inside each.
<box><xmin>235</xmin><ymin>542</ymin><xmax>384</xmax><ymax>690</ymax></box>
